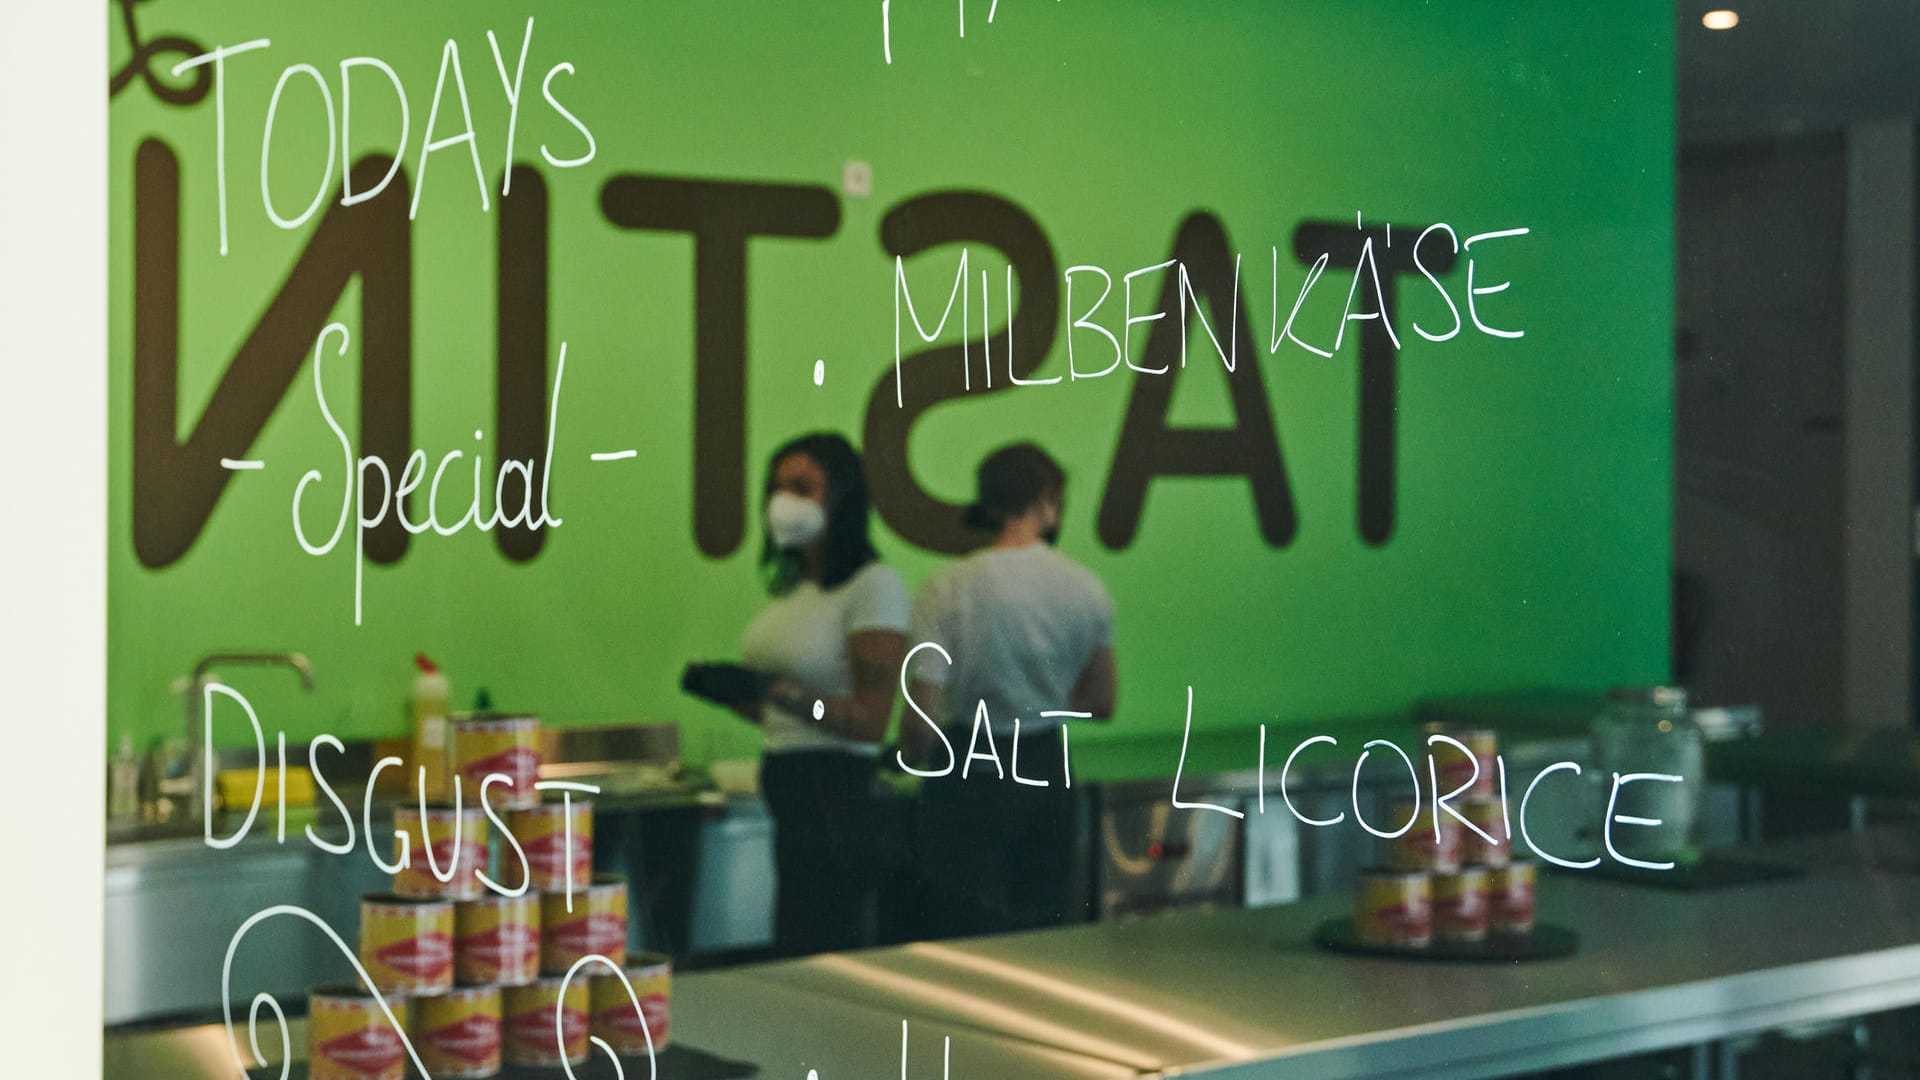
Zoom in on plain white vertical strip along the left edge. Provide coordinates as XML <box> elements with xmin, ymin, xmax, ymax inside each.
<box><xmin>0</xmin><ymin>4</ymin><xmax>108</xmax><ymax>1076</ymax></box>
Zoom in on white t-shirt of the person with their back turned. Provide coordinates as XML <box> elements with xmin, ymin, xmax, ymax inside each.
<box><xmin>906</xmin><ymin>544</ymin><xmax>1114</xmax><ymax>736</ymax></box>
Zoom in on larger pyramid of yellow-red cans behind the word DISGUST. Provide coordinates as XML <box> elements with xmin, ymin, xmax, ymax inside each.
<box><xmin>307</xmin><ymin>717</ymin><xmax>672</xmax><ymax>1080</ymax></box>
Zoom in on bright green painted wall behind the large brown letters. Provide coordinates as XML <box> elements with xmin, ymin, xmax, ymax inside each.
<box><xmin>105</xmin><ymin>0</ymin><xmax>1674</xmax><ymax>755</ymax></box>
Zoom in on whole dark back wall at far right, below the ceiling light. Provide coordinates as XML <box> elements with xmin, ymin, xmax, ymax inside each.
<box><xmin>1674</xmin><ymin>121</ymin><xmax>1916</xmax><ymax>728</ymax></box>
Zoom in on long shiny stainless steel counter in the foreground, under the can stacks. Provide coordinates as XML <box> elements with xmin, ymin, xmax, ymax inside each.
<box><xmin>106</xmin><ymin>828</ymin><xmax>1920</xmax><ymax>1080</ymax></box>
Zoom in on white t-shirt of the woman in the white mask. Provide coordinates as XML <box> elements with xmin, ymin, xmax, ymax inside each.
<box><xmin>739</xmin><ymin>559</ymin><xmax>908</xmax><ymax>755</ymax></box>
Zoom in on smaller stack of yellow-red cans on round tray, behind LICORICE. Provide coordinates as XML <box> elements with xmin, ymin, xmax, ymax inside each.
<box><xmin>1354</xmin><ymin>730</ymin><xmax>1534</xmax><ymax>949</ymax></box>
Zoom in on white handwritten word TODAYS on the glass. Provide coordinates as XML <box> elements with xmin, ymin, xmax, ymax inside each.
<box><xmin>173</xmin><ymin>17</ymin><xmax>595</xmax><ymax>256</ymax></box>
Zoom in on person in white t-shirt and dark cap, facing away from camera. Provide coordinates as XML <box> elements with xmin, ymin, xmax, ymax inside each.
<box><xmin>900</xmin><ymin>444</ymin><xmax>1117</xmax><ymax>936</ymax></box>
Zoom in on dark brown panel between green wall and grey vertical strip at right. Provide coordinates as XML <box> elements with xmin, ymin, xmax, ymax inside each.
<box><xmin>1674</xmin><ymin>135</ymin><xmax>1847</xmax><ymax>726</ymax></box>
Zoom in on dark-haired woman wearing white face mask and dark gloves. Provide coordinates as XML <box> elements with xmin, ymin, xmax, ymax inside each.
<box><xmin>682</xmin><ymin>434</ymin><xmax>910</xmax><ymax>955</ymax></box>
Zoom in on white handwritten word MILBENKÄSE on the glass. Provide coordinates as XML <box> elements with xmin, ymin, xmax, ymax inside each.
<box><xmin>893</xmin><ymin>215</ymin><xmax>1530</xmax><ymax>407</ymax></box>
